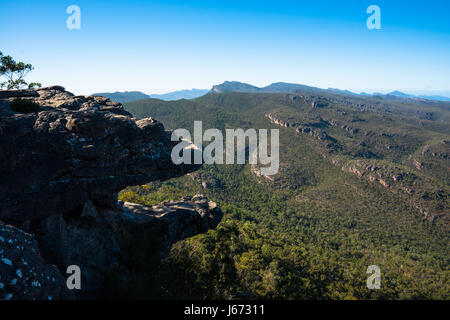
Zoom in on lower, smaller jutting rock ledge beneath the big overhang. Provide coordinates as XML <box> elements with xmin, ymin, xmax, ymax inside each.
<box><xmin>33</xmin><ymin>195</ymin><xmax>223</xmax><ymax>298</ymax></box>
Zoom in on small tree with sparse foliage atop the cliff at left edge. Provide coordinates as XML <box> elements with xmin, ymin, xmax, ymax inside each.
<box><xmin>0</xmin><ymin>51</ymin><xmax>41</xmax><ymax>90</ymax></box>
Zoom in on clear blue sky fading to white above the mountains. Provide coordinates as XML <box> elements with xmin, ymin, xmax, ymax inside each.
<box><xmin>0</xmin><ymin>0</ymin><xmax>450</xmax><ymax>96</ymax></box>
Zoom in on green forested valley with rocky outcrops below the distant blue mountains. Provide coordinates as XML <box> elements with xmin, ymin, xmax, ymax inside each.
<box><xmin>118</xmin><ymin>89</ymin><xmax>450</xmax><ymax>299</ymax></box>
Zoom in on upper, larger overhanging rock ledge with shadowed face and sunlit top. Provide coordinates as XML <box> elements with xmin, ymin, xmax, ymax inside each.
<box><xmin>0</xmin><ymin>87</ymin><xmax>198</xmax><ymax>221</ymax></box>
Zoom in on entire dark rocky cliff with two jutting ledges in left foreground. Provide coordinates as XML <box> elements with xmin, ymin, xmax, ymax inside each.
<box><xmin>0</xmin><ymin>86</ymin><xmax>222</xmax><ymax>299</ymax></box>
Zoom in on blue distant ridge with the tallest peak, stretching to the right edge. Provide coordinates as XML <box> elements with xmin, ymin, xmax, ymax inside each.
<box><xmin>211</xmin><ymin>81</ymin><xmax>450</xmax><ymax>101</ymax></box>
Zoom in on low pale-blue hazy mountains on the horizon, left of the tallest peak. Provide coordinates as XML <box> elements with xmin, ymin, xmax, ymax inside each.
<box><xmin>93</xmin><ymin>89</ymin><xmax>209</xmax><ymax>103</ymax></box>
